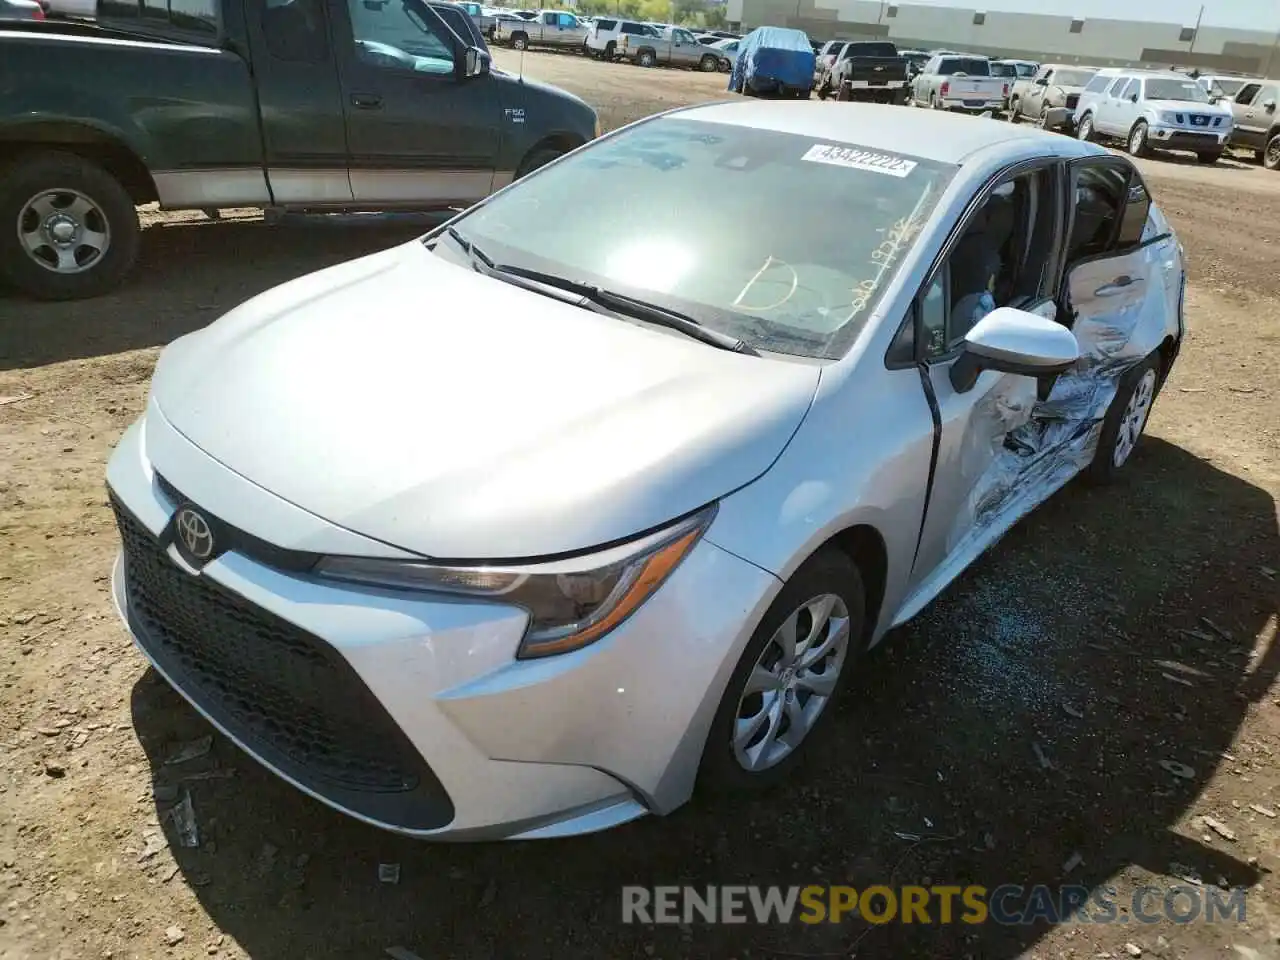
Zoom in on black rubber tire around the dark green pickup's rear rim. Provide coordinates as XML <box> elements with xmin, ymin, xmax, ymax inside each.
<box><xmin>0</xmin><ymin>151</ymin><xmax>142</xmax><ymax>300</ymax></box>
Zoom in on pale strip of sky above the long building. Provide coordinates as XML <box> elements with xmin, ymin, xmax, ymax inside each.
<box><xmin>910</xmin><ymin>0</ymin><xmax>1280</xmax><ymax>31</ymax></box>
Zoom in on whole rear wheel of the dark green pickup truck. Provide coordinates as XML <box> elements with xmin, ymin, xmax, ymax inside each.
<box><xmin>0</xmin><ymin>152</ymin><xmax>141</xmax><ymax>300</ymax></box>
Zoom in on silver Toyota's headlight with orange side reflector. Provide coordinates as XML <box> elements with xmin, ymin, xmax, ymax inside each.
<box><xmin>315</xmin><ymin>504</ymin><xmax>716</xmax><ymax>659</ymax></box>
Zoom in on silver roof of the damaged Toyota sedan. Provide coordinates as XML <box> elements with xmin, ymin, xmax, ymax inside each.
<box><xmin>672</xmin><ymin>100</ymin><xmax>1106</xmax><ymax>164</ymax></box>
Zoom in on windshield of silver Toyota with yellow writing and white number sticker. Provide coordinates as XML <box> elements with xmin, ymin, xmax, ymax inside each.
<box><xmin>442</xmin><ymin>118</ymin><xmax>956</xmax><ymax>358</ymax></box>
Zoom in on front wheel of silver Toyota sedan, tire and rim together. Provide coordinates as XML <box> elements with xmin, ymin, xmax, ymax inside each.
<box><xmin>700</xmin><ymin>549</ymin><xmax>865</xmax><ymax>791</ymax></box>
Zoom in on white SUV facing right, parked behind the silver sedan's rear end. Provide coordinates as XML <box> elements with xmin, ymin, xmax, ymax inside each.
<box><xmin>1075</xmin><ymin>68</ymin><xmax>1233</xmax><ymax>164</ymax></box>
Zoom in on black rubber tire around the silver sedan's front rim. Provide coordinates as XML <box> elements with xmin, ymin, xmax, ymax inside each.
<box><xmin>699</xmin><ymin>548</ymin><xmax>867</xmax><ymax>794</ymax></box>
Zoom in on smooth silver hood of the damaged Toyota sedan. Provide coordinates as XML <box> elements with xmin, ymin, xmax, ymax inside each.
<box><xmin>152</xmin><ymin>241</ymin><xmax>820</xmax><ymax>559</ymax></box>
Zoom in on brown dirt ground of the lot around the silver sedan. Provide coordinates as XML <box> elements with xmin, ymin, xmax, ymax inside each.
<box><xmin>0</xmin><ymin>51</ymin><xmax>1280</xmax><ymax>960</ymax></box>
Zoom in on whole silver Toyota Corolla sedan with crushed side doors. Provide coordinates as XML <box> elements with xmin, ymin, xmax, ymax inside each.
<box><xmin>108</xmin><ymin>102</ymin><xmax>1184</xmax><ymax>838</ymax></box>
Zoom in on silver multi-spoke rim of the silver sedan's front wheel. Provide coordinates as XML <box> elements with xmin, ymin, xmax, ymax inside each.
<box><xmin>732</xmin><ymin>594</ymin><xmax>850</xmax><ymax>773</ymax></box>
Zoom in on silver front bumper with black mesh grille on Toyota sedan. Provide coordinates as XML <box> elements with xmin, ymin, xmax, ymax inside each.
<box><xmin>108</xmin><ymin>406</ymin><xmax>778</xmax><ymax>840</ymax></box>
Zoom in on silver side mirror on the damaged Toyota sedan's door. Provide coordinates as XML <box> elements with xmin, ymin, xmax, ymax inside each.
<box><xmin>951</xmin><ymin>307</ymin><xmax>1080</xmax><ymax>393</ymax></box>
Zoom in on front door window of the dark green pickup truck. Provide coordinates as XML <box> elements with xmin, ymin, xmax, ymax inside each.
<box><xmin>347</xmin><ymin>0</ymin><xmax>454</xmax><ymax>76</ymax></box>
